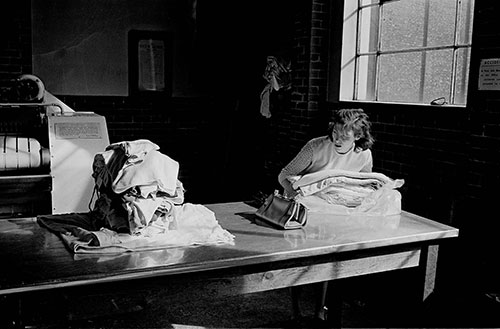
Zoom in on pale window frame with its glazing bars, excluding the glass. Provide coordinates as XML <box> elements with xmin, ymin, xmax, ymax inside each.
<box><xmin>334</xmin><ymin>0</ymin><xmax>475</xmax><ymax>107</ymax></box>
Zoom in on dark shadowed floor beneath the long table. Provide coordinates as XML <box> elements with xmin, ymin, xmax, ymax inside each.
<box><xmin>19</xmin><ymin>266</ymin><xmax>500</xmax><ymax>329</ymax></box>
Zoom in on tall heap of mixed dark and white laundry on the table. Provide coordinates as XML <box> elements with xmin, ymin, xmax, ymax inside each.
<box><xmin>38</xmin><ymin>139</ymin><xmax>234</xmax><ymax>253</ymax></box>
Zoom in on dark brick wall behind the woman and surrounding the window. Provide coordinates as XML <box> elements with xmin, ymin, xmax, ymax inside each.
<box><xmin>0</xmin><ymin>0</ymin><xmax>500</xmax><ymax>290</ymax></box>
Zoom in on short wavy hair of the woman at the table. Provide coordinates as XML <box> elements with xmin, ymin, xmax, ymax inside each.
<box><xmin>328</xmin><ymin>109</ymin><xmax>374</xmax><ymax>151</ymax></box>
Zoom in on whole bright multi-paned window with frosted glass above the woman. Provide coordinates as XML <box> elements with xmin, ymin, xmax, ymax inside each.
<box><xmin>340</xmin><ymin>0</ymin><xmax>474</xmax><ymax>105</ymax></box>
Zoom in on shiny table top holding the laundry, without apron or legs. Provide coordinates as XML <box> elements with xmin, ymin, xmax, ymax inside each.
<box><xmin>0</xmin><ymin>202</ymin><xmax>458</xmax><ymax>294</ymax></box>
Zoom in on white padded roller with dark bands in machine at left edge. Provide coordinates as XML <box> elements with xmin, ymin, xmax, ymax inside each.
<box><xmin>0</xmin><ymin>136</ymin><xmax>45</xmax><ymax>170</ymax></box>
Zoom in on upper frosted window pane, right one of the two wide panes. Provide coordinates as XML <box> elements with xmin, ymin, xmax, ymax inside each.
<box><xmin>427</xmin><ymin>0</ymin><xmax>457</xmax><ymax>46</ymax></box>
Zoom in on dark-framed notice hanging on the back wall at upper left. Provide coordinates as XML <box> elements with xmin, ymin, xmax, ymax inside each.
<box><xmin>128</xmin><ymin>30</ymin><xmax>172</xmax><ymax>96</ymax></box>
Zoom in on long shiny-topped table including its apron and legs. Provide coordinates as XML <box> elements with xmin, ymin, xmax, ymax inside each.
<box><xmin>0</xmin><ymin>202</ymin><xmax>458</xmax><ymax>327</ymax></box>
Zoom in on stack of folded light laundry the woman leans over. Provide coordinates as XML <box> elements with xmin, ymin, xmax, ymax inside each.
<box><xmin>292</xmin><ymin>169</ymin><xmax>404</xmax><ymax>215</ymax></box>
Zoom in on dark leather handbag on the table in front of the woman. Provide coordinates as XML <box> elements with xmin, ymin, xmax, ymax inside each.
<box><xmin>255</xmin><ymin>191</ymin><xmax>307</xmax><ymax>230</ymax></box>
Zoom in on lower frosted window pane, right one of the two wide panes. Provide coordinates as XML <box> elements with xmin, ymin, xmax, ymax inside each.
<box><xmin>422</xmin><ymin>49</ymin><xmax>453</xmax><ymax>104</ymax></box>
